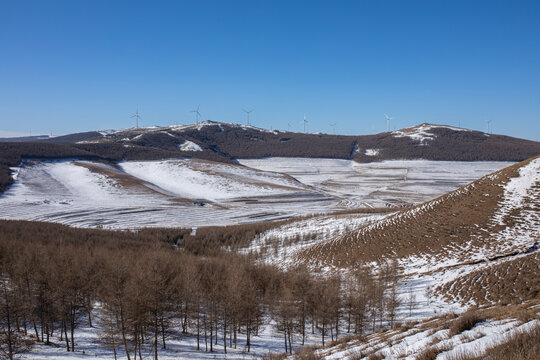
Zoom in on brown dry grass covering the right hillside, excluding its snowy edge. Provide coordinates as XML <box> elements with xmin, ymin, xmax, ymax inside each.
<box><xmin>300</xmin><ymin>160</ymin><xmax>530</xmax><ymax>267</ymax></box>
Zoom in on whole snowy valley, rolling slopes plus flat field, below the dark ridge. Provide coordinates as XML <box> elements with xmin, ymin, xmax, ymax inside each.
<box><xmin>0</xmin><ymin>158</ymin><xmax>509</xmax><ymax>228</ymax></box>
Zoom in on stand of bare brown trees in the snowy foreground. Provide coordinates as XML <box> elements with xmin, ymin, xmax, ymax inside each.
<box><xmin>0</xmin><ymin>222</ymin><xmax>400</xmax><ymax>360</ymax></box>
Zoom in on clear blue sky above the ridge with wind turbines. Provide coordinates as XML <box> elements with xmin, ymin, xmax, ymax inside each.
<box><xmin>0</xmin><ymin>0</ymin><xmax>540</xmax><ymax>140</ymax></box>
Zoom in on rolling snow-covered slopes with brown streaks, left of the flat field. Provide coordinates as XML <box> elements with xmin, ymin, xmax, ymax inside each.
<box><xmin>0</xmin><ymin>160</ymin><xmax>330</xmax><ymax>229</ymax></box>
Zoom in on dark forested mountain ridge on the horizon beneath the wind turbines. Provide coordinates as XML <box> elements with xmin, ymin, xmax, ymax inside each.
<box><xmin>0</xmin><ymin>121</ymin><xmax>540</xmax><ymax>193</ymax></box>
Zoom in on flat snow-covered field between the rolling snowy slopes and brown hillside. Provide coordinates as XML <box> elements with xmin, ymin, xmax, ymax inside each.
<box><xmin>239</xmin><ymin>157</ymin><xmax>512</xmax><ymax>206</ymax></box>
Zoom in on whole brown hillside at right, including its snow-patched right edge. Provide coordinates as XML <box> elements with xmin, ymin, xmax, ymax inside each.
<box><xmin>299</xmin><ymin>157</ymin><xmax>540</xmax><ymax>267</ymax></box>
